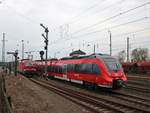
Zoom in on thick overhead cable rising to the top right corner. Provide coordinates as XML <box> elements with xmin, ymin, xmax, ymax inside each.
<box><xmin>72</xmin><ymin>2</ymin><xmax>150</xmax><ymax>34</ymax></box>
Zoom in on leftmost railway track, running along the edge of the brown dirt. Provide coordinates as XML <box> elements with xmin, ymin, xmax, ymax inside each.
<box><xmin>30</xmin><ymin>79</ymin><xmax>115</xmax><ymax>113</ymax></box>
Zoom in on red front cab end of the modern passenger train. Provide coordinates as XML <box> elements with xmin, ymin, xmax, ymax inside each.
<box><xmin>97</xmin><ymin>54</ymin><xmax>127</xmax><ymax>88</ymax></box>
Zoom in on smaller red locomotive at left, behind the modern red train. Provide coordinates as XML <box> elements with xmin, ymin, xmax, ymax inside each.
<box><xmin>18</xmin><ymin>59</ymin><xmax>37</xmax><ymax>77</ymax></box>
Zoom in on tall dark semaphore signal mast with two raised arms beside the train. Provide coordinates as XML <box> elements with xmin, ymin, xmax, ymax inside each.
<box><xmin>40</xmin><ymin>24</ymin><xmax>49</xmax><ymax>75</ymax></box>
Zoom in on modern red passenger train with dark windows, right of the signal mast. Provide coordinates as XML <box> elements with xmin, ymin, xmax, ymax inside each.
<box><xmin>35</xmin><ymin>54</ymin><xmax>127</xmax><ymax>88</ymax></box>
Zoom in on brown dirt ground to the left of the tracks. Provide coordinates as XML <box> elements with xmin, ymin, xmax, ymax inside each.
<box><xmin>6</xmin><ymin>75</ymin><xmax>88</xmax><ymax>113</ymax></box>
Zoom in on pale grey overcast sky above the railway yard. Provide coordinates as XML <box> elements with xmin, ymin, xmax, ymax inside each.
<box><xmin>0</xmin><ymin>0</ymin><xmax>150</xmax><ymax>60</ymax></box>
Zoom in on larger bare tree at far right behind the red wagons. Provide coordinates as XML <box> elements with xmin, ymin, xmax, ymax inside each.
<box><xmin>131</xmin><ymin>48</ymin><xmax>148</xmax><ymax>61</ymax></box>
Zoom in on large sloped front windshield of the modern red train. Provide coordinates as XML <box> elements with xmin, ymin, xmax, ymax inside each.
<box><xmin>103</xmin><ymin>58</ymin><xmax>121</xmax><ymax>72</ymax></box>
